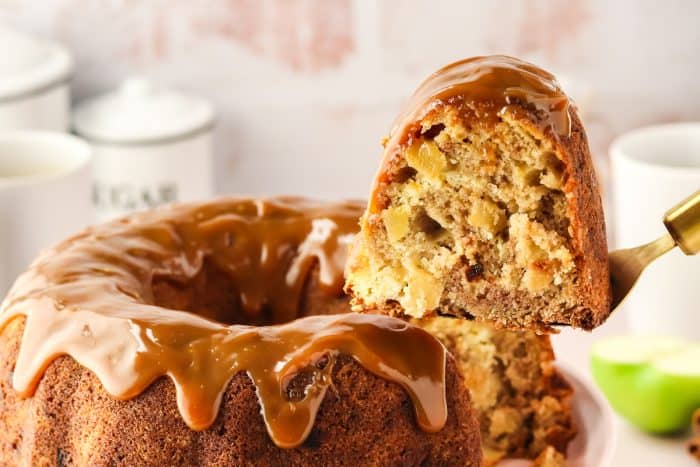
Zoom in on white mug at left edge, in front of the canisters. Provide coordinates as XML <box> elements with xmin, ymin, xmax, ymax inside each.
<box><xmin>0</xmin><ymin>130</ymin><xmax>94</xmax><ymax>299</ymax></box>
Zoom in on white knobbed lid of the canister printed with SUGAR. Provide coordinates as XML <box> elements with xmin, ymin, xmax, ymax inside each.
<box><xmin>73</xmin><ymin>77</ymin><xmax>214</xmax><ymax>144</ymax></box>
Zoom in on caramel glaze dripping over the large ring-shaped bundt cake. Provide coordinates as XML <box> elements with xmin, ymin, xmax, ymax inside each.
<box><xmin>0</xmin><ymin>198</ymin><xmax>447</xmax><ymax>447</ymax></box>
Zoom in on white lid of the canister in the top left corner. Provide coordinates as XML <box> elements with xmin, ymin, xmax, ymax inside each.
<box><xmin>0</xmin><ymin>26</ymin><xmax>73</xmax><ymax>101</ymax></box>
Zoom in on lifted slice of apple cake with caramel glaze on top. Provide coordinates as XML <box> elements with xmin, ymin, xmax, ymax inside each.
<box><xmin>346</xmin><ymin>56</ymin><xmax>611</xmax><ymax>330</ymax></box>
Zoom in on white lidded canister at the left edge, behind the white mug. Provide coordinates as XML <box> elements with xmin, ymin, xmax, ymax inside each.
<box><xmin>0</xmin><ymin>26</ymin><xmax>73</xmax><ymax>131</ymax></box>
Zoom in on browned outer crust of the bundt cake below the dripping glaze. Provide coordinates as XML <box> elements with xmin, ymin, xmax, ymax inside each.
<box><xmin>0</xmin><ymin>320</ymin><xmax>481</xmax><ymax>466</ymax></box>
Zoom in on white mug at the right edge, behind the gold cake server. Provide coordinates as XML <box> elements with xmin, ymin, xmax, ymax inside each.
<box><xmin>610</xmin><ymin>122</ymin><xmax>700</xmax><ymax>340</ymax></box>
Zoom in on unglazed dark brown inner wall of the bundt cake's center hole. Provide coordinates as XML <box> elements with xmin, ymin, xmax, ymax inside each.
<box><xmin>151</xmin><ymin>258</ymin><xmax>350</xmax><ymax>326</ymax></box>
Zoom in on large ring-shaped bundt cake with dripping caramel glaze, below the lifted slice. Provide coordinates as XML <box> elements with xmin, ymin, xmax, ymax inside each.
<box><xmin>0</xmin><ymin>199</ymin><xmax>481</xmax><ymax>466</ymax></box>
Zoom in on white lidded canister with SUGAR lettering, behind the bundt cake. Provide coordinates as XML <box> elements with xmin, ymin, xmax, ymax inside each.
<box><xmin>73</xmin><ymin>78</ymin><xmax>214</xmax><ymax>221</ymax></box>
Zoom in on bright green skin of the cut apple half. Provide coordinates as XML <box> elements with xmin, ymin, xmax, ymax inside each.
<box><xmin>591</xmin><ymin>353</ymin><xmax>700</xmax><ymax>434</ymax></box>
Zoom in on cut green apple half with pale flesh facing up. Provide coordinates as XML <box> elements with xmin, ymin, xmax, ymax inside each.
<box><xmin>591</xmin><ymin>336</ymin><xmax>700</xmax><ymax>434</ymax></box>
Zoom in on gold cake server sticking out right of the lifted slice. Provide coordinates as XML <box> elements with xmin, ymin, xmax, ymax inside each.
<box><xmin>609</xmin><ymin>190</ymin><xmax>700</xmax><ymax>311</ymax></box>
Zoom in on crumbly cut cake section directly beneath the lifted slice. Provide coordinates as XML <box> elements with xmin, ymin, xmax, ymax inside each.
<box><xmin>413</xmin><ymin>317</ymin><xmax>576</xmax><ymax>466</ymax></box>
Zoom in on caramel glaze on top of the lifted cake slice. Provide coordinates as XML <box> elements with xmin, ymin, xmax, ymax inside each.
<box><xmin>370</xmin><ymin>55</ymin><xmax>572</xmax><ymax>213</ymax></box>
